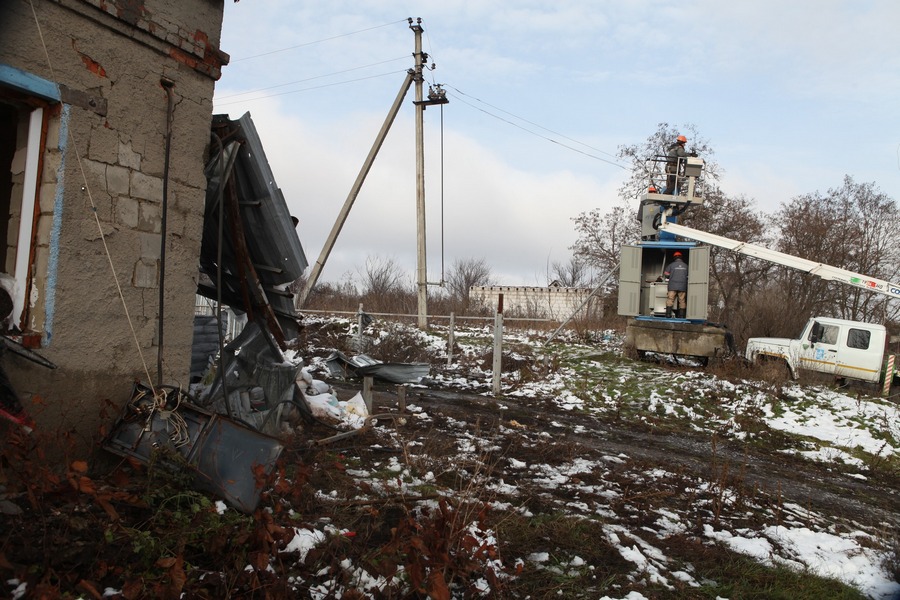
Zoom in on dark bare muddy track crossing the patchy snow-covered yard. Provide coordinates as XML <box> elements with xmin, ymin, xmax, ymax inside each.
<box><xmin>346</xmin><ymin>386</ymin><xmax>900</xmax><ymax>527</ymax></box>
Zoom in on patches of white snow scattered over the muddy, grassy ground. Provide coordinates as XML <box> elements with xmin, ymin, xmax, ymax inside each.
<box><xmin>284</xmin><ymin>322</ymin><xmax>900</xmax><ymax>600</ymax></box>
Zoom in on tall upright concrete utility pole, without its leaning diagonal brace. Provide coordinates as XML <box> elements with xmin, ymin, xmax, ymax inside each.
<box><xmin>409</xmin><ymin>17</ymin><xmax>428</xmax><ymax>329</ymax></box>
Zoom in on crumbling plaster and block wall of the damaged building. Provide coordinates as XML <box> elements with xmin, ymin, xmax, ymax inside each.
<box><xmin>0</xmin><ymin>0</ymin><xmax>227</xmax><ymax>445</ymax></box>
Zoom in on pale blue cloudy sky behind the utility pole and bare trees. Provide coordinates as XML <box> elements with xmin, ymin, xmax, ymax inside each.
<box><xmin>215</xmin><ymin>0</ymin><xmax>900</xmax><ymax>285</ymax></box>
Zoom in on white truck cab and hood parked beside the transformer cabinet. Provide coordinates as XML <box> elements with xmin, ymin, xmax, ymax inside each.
<box><xmin>745</xmin><ymin>317</ymin><xmax>893</xmax><ymax>383</ymax></box>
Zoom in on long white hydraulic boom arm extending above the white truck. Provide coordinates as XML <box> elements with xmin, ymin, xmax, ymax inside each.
<box><xmin>659</xmin><ymin>219</ymin><xmax>900</xmax><ymax>298</ymax></box>
